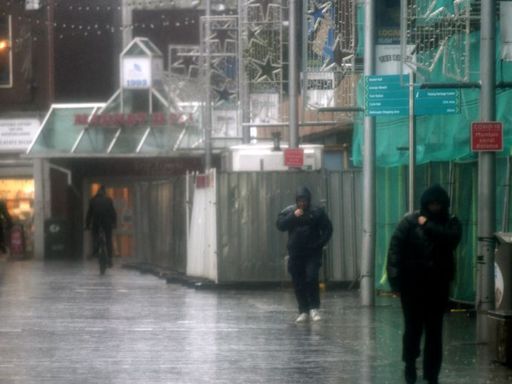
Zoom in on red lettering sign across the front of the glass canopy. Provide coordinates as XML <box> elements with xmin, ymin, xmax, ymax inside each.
<box><xmin>75</xmin><ymin>112</ymin><xmax>193</xmax><ymax>128</ymax></box>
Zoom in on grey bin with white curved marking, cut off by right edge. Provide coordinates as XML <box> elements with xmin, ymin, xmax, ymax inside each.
<box><xmin>494</xmin><ymin>232</ymin><xmax>512</xmax><ymax>311</ymax></box>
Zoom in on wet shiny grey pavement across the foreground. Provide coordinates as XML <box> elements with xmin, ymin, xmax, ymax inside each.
<box><xmin>0</xmin><ymin>260</ymin><xmax>512</xmax><ymax>384</ymax></box>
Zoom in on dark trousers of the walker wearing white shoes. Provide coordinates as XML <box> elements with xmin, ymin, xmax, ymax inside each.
<box><xmin>288</xmin><ymin>256</ymin><xmax>322</xmax><ymax>313</ymax></box>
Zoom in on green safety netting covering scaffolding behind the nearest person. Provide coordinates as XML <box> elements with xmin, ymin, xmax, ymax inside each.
<box><xmin>353</xmin><ymin>1</ymin><xmax>512</xmax><ymax>303</ymax></box>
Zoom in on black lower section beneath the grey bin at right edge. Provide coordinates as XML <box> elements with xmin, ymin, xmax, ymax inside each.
<box><xmin>489</xmin><ymin>310</ymin><xmax>512</xmax><ymax>367</ymax></box>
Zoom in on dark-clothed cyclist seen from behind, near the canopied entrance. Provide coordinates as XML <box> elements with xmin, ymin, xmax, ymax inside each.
<box><xmin>85</xmin><ymin>185</ymin><xmax>117</xmax><ymax>267</ymax></box>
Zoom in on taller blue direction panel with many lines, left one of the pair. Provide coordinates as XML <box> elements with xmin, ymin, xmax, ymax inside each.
<box><xmin>365</xmin><ymin>75</ymin><xmax>409</xmax><ymax>116</ymax></box>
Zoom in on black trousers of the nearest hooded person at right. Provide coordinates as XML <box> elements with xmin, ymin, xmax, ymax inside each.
<box><xmin>400</xmin><ymin>287</ymin><xmax>448</xmax><ymax>380</ymax></box>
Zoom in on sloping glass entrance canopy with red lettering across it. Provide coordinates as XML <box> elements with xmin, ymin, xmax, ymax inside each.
<box><xmin>27</xmin><ymin>89</ymin><xmax>204</xmax><ymax>158</ymax></box>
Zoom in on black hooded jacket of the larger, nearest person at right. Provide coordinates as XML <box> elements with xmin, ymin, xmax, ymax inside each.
<box><xmin>387</xmin><ymin>185</ymin><xmax>462</xmax><ymax>292</ymax></box>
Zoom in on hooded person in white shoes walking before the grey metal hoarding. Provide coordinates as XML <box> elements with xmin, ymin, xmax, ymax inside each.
<box><xmin>276</xmin><ymin>187</ymin><xmax>332</xmax><ymax>323</ymax></box>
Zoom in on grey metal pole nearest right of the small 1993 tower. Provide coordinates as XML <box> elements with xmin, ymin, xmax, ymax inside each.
<box><xmin>203</xmin><ymin>0</ymin><xmax>212</xmax><ymax>172</ymax></box>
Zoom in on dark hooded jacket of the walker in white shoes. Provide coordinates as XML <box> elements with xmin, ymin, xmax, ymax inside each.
<box><xmin>276</xmin><ymin>187</ymin><xmax>332</xmax><ymax>257</ymax></box>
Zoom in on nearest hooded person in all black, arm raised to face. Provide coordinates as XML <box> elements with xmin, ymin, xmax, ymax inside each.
<box><xmin>387</xmin><ymin>184</ymin><xmax>462</xmax><ymax>384</ymax></box>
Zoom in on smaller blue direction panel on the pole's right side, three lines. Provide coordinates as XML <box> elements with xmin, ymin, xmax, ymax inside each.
<box><xmin>414</xmin><ymin>88</ymin><xmax>460</xmax><ymax>115</ymax></box>
